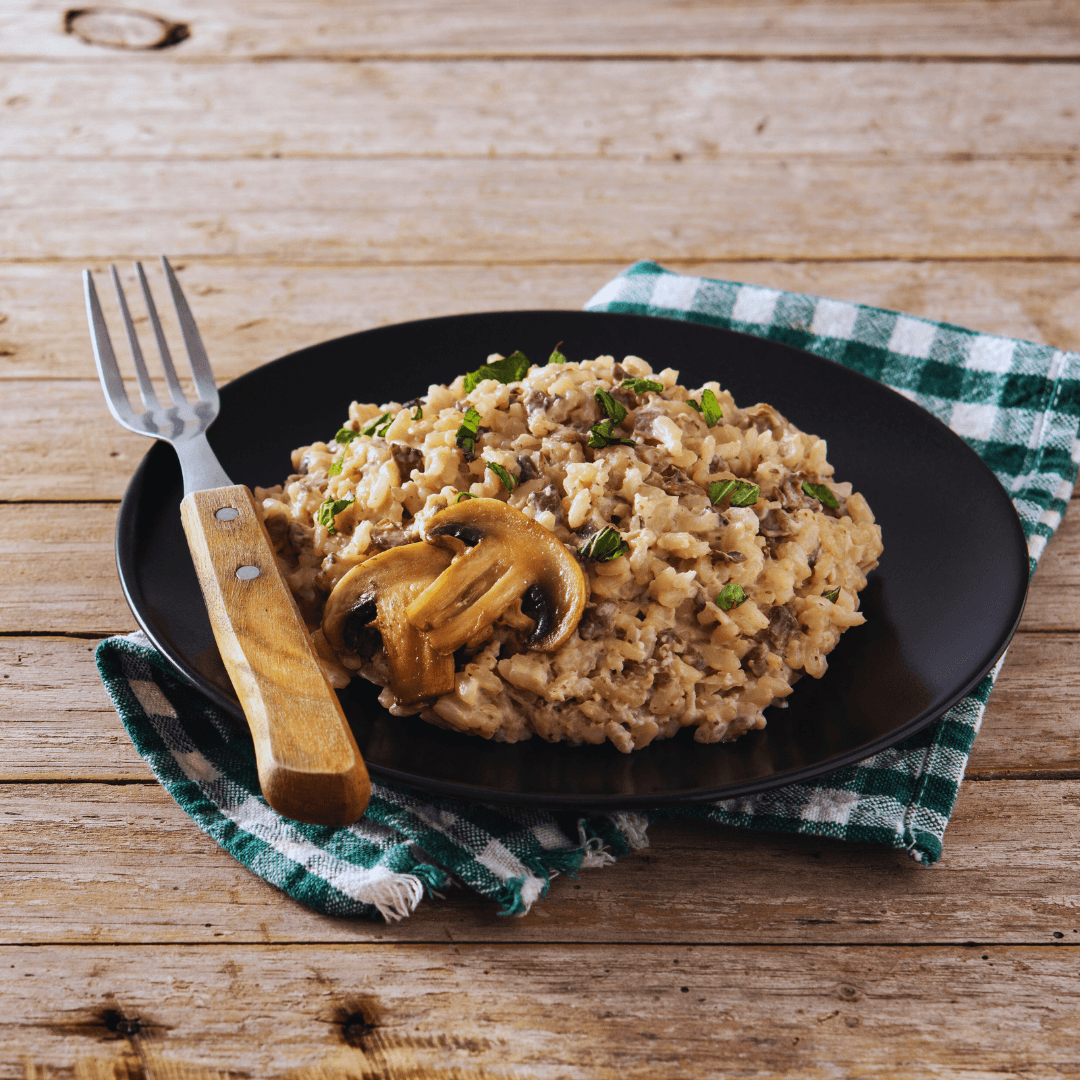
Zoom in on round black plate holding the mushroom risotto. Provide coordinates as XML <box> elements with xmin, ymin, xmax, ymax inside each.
<box><xmin>117</xmin><ymin>311</ymin><xmax>1028</xmax><ymax>808</ymax></box>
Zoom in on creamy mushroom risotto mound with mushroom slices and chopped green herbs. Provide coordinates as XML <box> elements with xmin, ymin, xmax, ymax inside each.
<box><xmin>255</xmin><ymin>349</ymin><xmax>881</xmax><ymax>752</ymax></box>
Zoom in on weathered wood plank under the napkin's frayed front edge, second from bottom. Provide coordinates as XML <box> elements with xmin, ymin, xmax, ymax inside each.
<box><xmin>0</xmin><ymin>780</ymin><xmax>1080</xmax><ymax>944</ymax></box>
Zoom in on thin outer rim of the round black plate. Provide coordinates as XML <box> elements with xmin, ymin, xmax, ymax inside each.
<box><xmin>114</xmin><ymin>308</ymin><xmax>1030</xmax><ymax>811</ymax></box>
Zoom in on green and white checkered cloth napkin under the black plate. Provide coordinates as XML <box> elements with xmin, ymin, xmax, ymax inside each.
<box><xmin>97</xmin><ymin>262</ymin><xmax>1080</xmax><ymax>918</ymax></box>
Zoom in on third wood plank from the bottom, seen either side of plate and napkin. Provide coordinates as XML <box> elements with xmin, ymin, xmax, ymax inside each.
<box><xmin>0</xmin><ymin>632</ymin><xmax>1080</xmax><ymax>783</ymax></box>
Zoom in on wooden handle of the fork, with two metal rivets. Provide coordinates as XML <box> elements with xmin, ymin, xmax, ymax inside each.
<box><xmin>180</xmin><ymin>485</ymin><xmax>370</xmax><ymax>825</ymax></box>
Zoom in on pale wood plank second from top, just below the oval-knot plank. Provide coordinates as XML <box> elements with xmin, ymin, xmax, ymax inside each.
<box><xmin>0</xmin><ymin>56</ymin><xmax>1080</xmax><ymax>159</ymax></box>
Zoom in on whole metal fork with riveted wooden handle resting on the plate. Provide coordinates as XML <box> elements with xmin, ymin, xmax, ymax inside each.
<box><xmin>83</xmin><ymin>256</ymin><xmax>370</xmax><ymax>825</ymax></box>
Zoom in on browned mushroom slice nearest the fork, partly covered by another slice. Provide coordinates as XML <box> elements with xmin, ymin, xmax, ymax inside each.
<box><xmin>323</xmin><ymin>543</ymin><xmax>454</xmax><ymax>705</ymax></box>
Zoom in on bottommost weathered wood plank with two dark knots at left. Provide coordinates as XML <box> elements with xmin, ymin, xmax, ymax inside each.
<box><xmin>6</xmin><ymin>943</ymin><xmax>1080</xmax><ymax>1080</ymax></box>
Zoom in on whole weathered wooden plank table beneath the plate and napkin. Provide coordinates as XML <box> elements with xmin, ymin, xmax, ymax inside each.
<box><xmin>0</xmin><ymin>0</ymin><xmax>1080</xmax><ymax>1080</ymax></box>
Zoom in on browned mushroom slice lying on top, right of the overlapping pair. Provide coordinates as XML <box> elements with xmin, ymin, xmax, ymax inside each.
<box><xmin>407</xmin><ymin>499</ymin><xmax>589</xmax><ymax>652</ymax></box>
